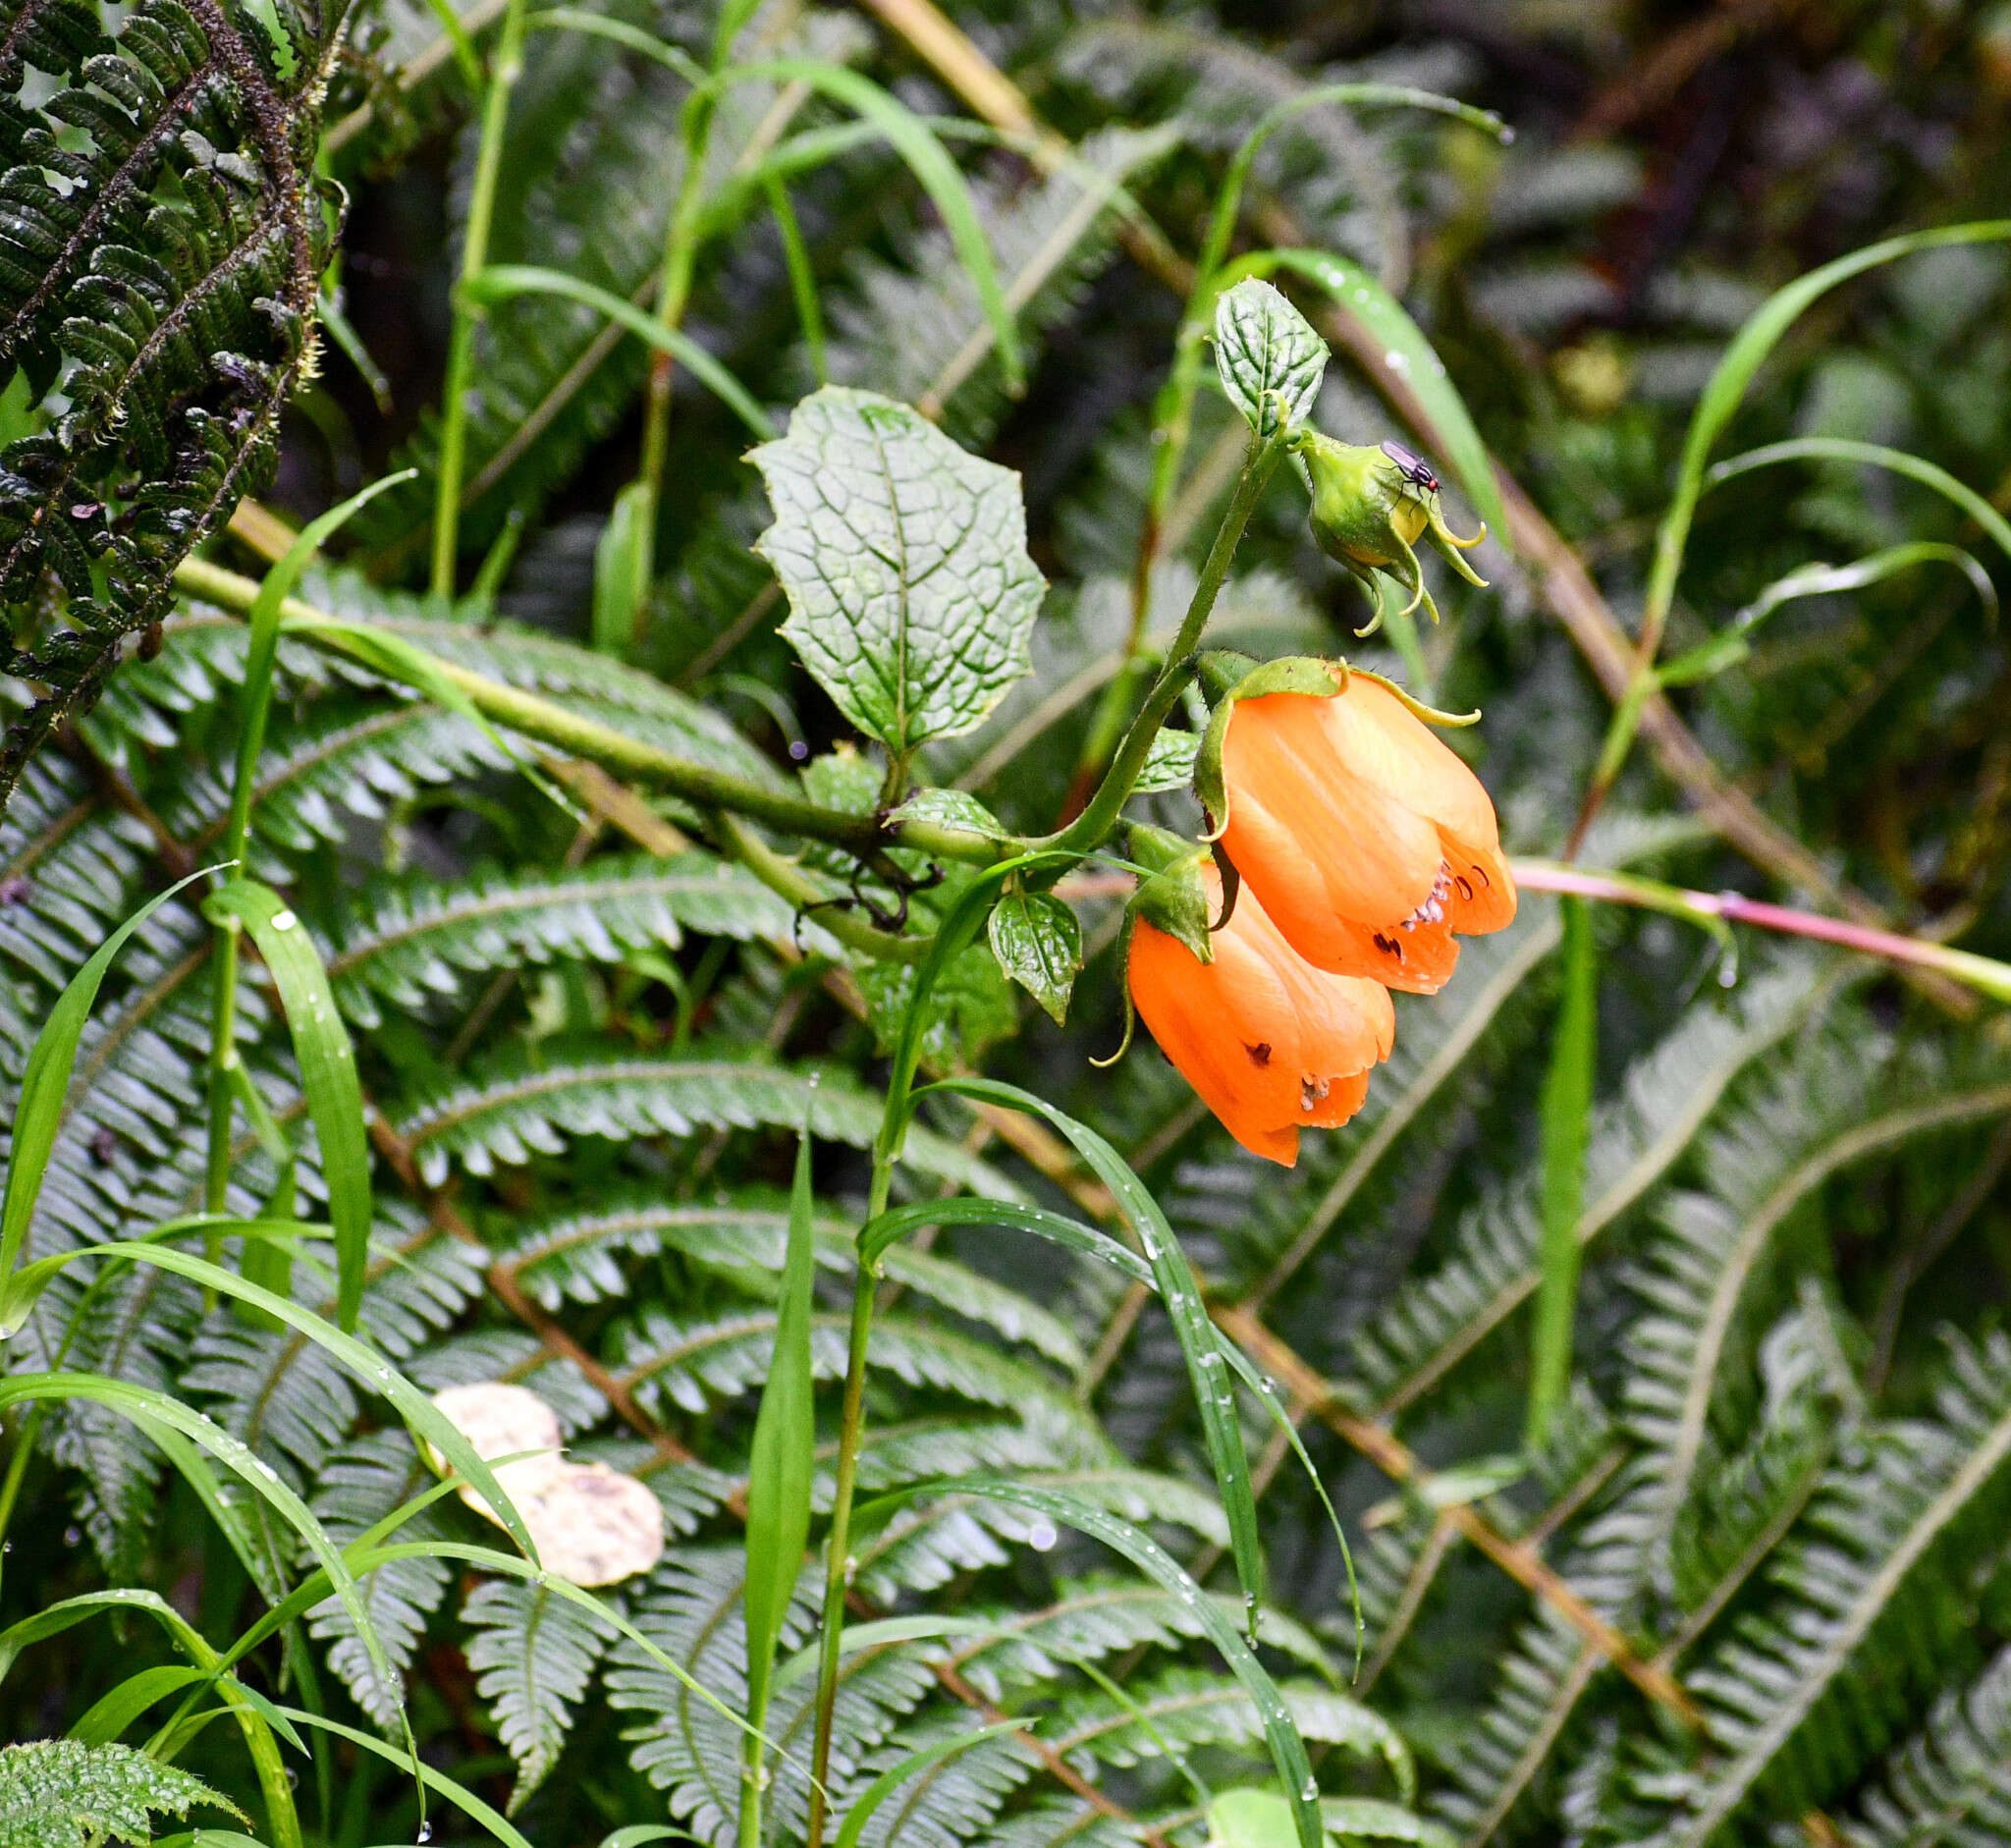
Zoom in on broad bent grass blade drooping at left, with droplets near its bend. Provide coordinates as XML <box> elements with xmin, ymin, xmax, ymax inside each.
<box><xmin>203</xmin><ymin>879</ymin><xmax>370</xmax><ymax>1335</ymax></box>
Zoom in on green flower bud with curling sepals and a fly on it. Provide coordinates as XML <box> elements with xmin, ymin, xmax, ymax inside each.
<box><xmin>1293</xmin><ymin>430</ymin><xmax>1489</xmax><ymax>635</ymax></box>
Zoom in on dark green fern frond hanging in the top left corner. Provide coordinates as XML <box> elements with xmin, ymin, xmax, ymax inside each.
<box><xmin>0</xmin><ymin>0</ymin><xmax>346</xmax><ymax>796</ymax></box>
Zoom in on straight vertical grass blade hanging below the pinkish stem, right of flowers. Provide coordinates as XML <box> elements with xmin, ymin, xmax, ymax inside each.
<box><xmin>1528</xmin><ymin>898</ymin><xmax>1599</xmax><ymax>1447</ymax></box>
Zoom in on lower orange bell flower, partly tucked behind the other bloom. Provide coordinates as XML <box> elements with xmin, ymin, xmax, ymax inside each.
<box><xmin>1128</xmin><ymin>867</ymin><xmax>1395</xmax><ymax>1169</ymax></box>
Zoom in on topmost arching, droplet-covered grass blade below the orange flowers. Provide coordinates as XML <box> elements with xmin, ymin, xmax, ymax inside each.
<box><xmin>931</xmin><ymin>1078</ymin><xmax>1263</xmax><ymax>1631</ymax></box>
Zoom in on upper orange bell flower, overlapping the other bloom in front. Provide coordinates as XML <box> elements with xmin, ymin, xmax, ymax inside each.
<box><xmin>1221</xmin><ymin>674</ymin><xmax>1516</xmax><ymax>996</ymax></box>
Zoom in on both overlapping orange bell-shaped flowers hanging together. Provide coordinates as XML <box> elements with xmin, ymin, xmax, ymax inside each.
<box><xmin>1130</xmin><ymin>674</ymin><xmax>1516</xmax><ymax>1167</ymax></box>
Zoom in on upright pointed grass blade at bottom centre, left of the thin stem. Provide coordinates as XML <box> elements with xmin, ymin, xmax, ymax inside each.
<box><xmin>740</xmin><ymin>1128</ymin><xmax>816</xmax><ymax>1844</ymax></box>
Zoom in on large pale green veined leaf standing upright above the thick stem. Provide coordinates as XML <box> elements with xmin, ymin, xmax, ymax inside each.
<box><xmin>752</xmin><ymin>386</ymin><xmax>1046</xmax><ymax>756</ymax></box>
